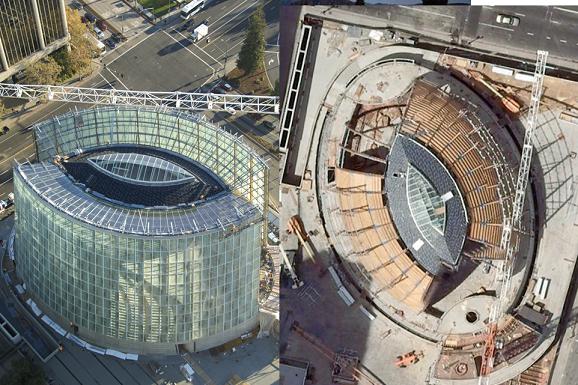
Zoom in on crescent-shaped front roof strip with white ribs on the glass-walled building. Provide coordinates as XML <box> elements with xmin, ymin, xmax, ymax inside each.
<box><xmin>14</xmin><ymin>162</ymin><xmax>260</xmax><ymax>236</ymax></box>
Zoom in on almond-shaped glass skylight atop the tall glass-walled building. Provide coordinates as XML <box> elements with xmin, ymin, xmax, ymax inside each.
<box><xmin>88</xmin><ymin>152</ymin><xmax>196</xmax><ymax>184</ymax></box>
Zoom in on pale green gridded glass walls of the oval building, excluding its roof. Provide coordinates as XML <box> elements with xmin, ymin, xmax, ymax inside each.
<box><xmin>14</xmin><ymin>108</ymin><xmax>267</xmax><ymax>350</ymax></box>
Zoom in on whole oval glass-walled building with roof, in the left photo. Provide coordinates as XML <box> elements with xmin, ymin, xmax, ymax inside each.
<box><xmin>14</xmin><ymin>107</ymin><xmax>268</xmax><ymax>354</ymax></box>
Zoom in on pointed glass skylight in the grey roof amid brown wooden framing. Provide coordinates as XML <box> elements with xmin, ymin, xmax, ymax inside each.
<box><xmin>407</xmin><ymin>164</ymin><xmax>446</xmax><ymax>239</ymax></box>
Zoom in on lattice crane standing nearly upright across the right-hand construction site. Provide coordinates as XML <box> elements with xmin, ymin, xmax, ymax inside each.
<box><xmin>479</xmin><ymin>51</ymin><xmax>548</xmax><ymax>385</ymax></box>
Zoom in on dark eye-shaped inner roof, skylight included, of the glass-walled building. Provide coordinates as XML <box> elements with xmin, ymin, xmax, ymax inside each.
<box><xmin>61</xmin><ymin>145</ymin><xmax>226</xmax><ymax>208</ymax></box>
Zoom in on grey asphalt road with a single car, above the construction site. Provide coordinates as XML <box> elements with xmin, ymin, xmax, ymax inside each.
<box><xmin>336</xmin><ymin>6</ymin><xmax>578</xmax><ymax>70</ymax></box>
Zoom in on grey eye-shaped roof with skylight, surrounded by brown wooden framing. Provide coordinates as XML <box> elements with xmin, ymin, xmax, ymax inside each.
<box><xmin>385</xmin><ymin>135</ymin><xmax>468</xmax><ymax>275</ymax></box>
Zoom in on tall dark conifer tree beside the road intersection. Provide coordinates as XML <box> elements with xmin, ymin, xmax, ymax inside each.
<box><xmin>237</xmin><ymin>3</ymin><xmax>267</xmax><ymax>74</ymax></box>
